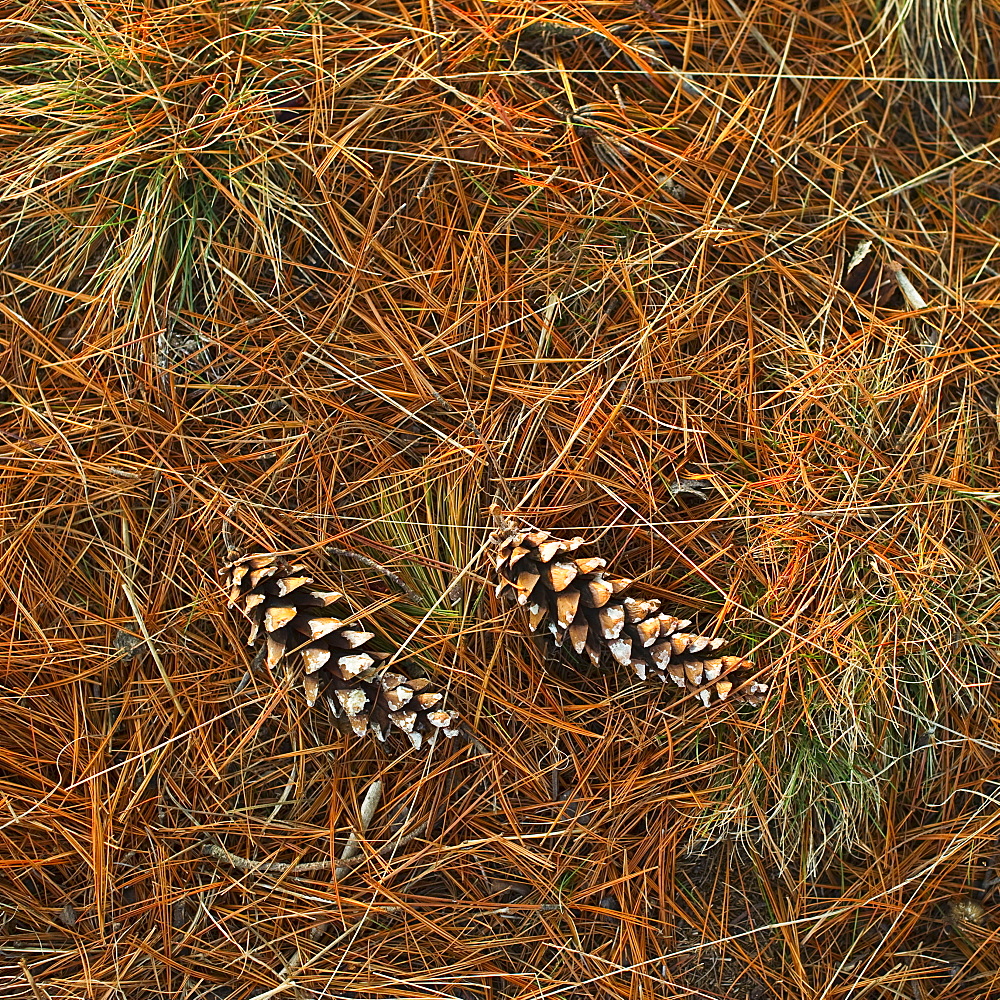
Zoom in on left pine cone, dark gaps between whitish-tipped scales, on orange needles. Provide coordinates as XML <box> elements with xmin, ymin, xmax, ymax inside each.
<box><xmin>222</xmin><ymin>552</ymin><xmax>459</xmax><ymax>748</ymax></box>
